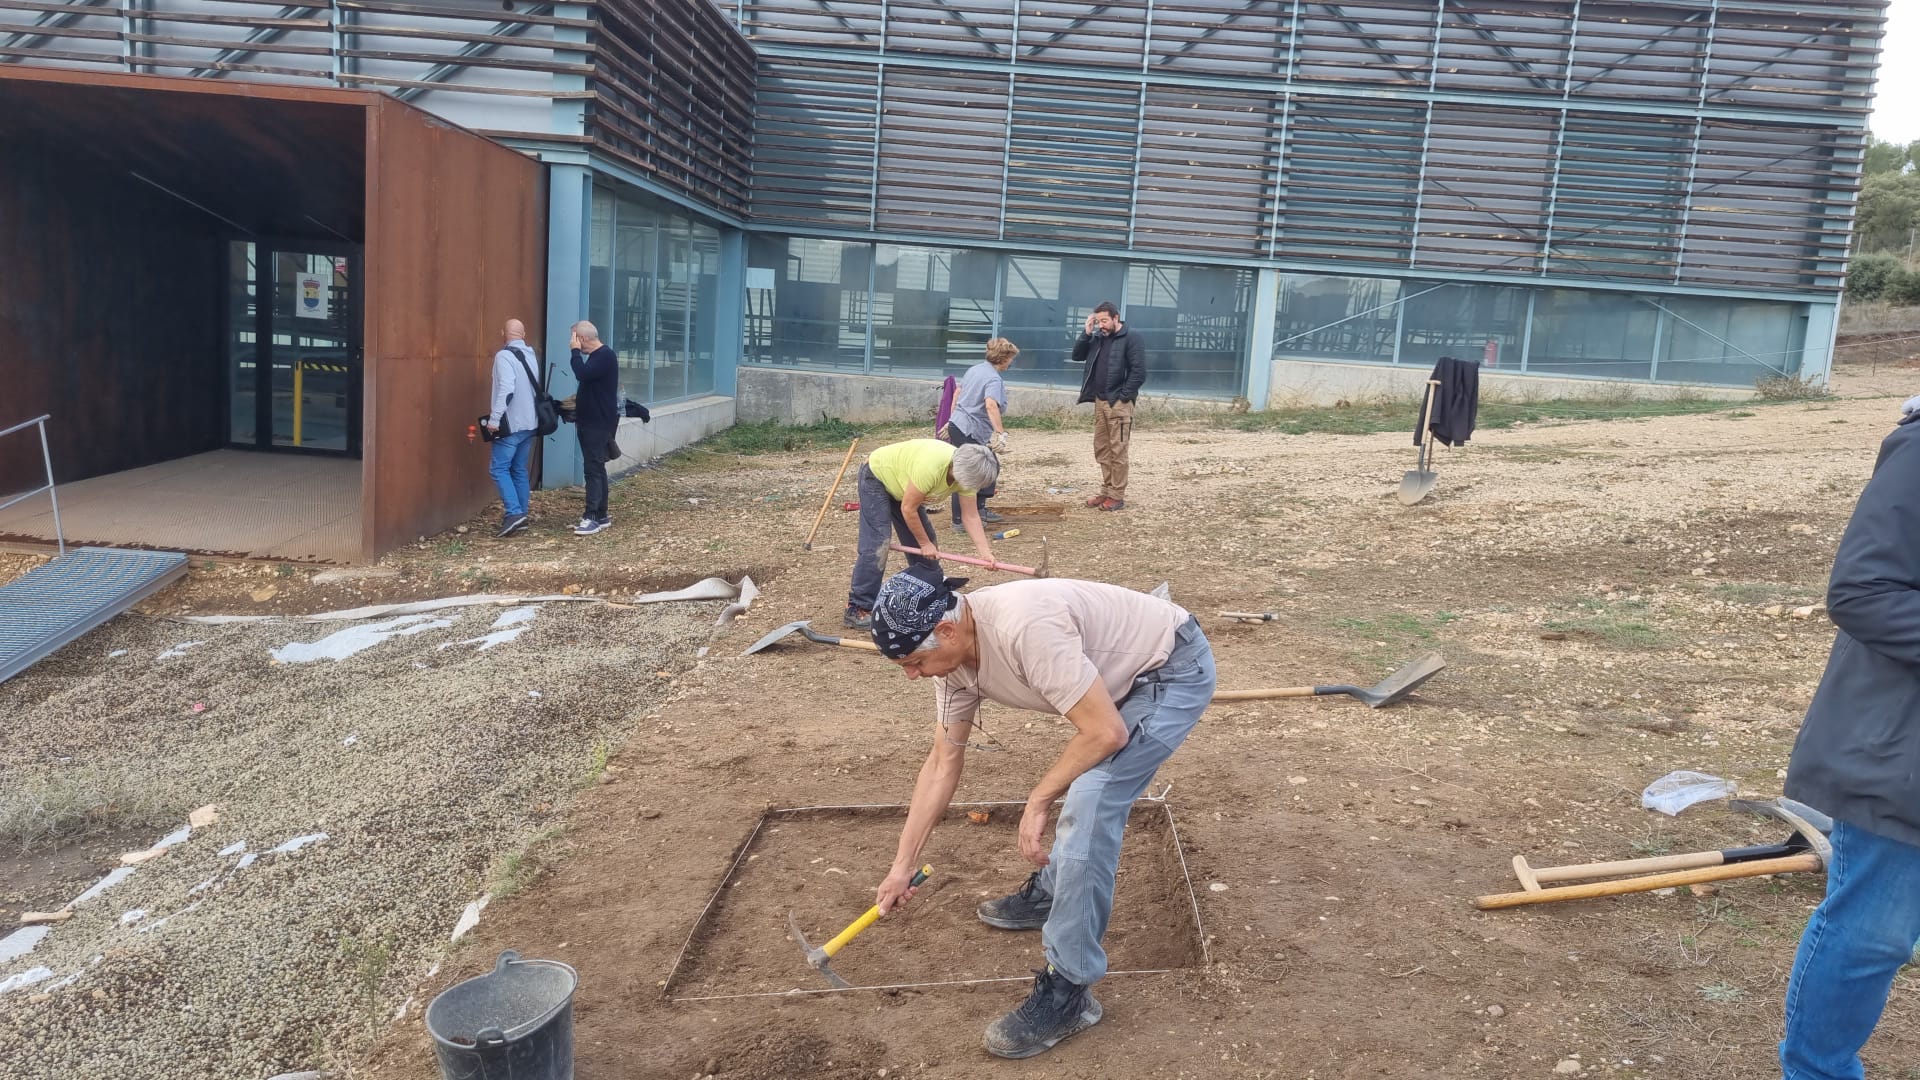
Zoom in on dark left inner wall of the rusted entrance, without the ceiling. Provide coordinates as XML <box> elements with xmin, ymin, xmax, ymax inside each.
<box><xmin>0</xmin><ymin>153</ymin><xmax>227</xmax><ymax>486</ymax></box>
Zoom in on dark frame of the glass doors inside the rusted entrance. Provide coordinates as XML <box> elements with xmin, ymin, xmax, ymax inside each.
<box><xmin>225</xmin><ymin>236</ymin><xmax>367</xmax><ymax>459</ymax></box>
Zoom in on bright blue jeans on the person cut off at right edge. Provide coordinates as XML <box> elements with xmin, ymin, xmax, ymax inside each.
<box><xmin>1780</xmin><ymin>822</ymin><xmax>1920</xmax><ymax>1080</ymax></box>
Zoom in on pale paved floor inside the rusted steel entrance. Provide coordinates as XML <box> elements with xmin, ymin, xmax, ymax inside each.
<box><xmin>0</xmin><ymin>450</ymin><xmax>361</xmax><ymax>563</ymax></box>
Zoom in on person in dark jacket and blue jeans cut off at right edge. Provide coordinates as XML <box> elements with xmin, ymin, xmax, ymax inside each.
<box><xmin>1780</xmin><ymin>403</ymin><xmax>1920</xmax><ymax>1080</ymax></box>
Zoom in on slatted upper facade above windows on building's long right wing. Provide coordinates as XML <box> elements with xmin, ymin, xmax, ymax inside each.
<box><xmin>718</xmin><ymin>0</ymin><xmax>1885</xmax><ymax>302</ymax></box>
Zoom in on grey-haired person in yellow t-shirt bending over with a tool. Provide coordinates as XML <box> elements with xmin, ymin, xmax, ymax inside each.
<box><xmin>841</xmin><ymin>438</ymin><xmax>1000</xmax><ymax>630</ymax></box>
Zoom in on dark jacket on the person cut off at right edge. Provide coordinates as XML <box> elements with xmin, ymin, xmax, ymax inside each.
<box><xmin>1786</xmin><ymin>417</ymin><xmax>1920</xmax><ymax>846</ymax></box>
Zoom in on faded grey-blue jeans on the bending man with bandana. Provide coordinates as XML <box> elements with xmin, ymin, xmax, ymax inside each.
<box><xmin>1039</xmin><ymin>619</ymin><xmax>1213</xmax><ymax>986</ymax></box>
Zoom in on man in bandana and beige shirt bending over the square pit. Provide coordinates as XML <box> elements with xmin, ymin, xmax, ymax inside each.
<box><xmin>872</xmin><ymin>565</ymin><xmax>1213</xmax><ymax>1057</ymax></box>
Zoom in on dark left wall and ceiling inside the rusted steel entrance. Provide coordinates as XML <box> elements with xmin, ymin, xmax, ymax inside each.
<box><xmin>0</xmin><ymin>67</ymin><xmax>376</xmax><ymax>488</ymax></box>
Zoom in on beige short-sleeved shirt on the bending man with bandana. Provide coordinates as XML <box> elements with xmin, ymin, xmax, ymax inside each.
<box><xmin>933</xmin><ymin>578</ymin><xmax>1190</xmax><ymax>724</ymax></box>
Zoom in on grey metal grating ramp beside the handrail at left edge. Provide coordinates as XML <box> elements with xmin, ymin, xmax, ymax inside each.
<box><xmin>0</xmin><ymin>548</ymin><xmax>186</xmax><ymax>682</ymax></box>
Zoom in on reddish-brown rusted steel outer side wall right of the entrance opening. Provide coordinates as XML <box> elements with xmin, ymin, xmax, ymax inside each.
<box><xmin>361</xmin><ymin>98</ymin><xmax>547</xmax><ymax>557</ymax></box>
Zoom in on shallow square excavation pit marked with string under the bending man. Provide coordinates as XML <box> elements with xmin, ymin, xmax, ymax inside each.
<box><xmin>670</xmin><ymin>803</ymin><xmax>1200</xmax><ymax>997</ymax></box>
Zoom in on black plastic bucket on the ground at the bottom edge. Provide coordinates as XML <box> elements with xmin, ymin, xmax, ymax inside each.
<box><xmin>426</xmin><ymin>949</ymin><xmax>580</xmax><ymax>1080</ymax></box>
